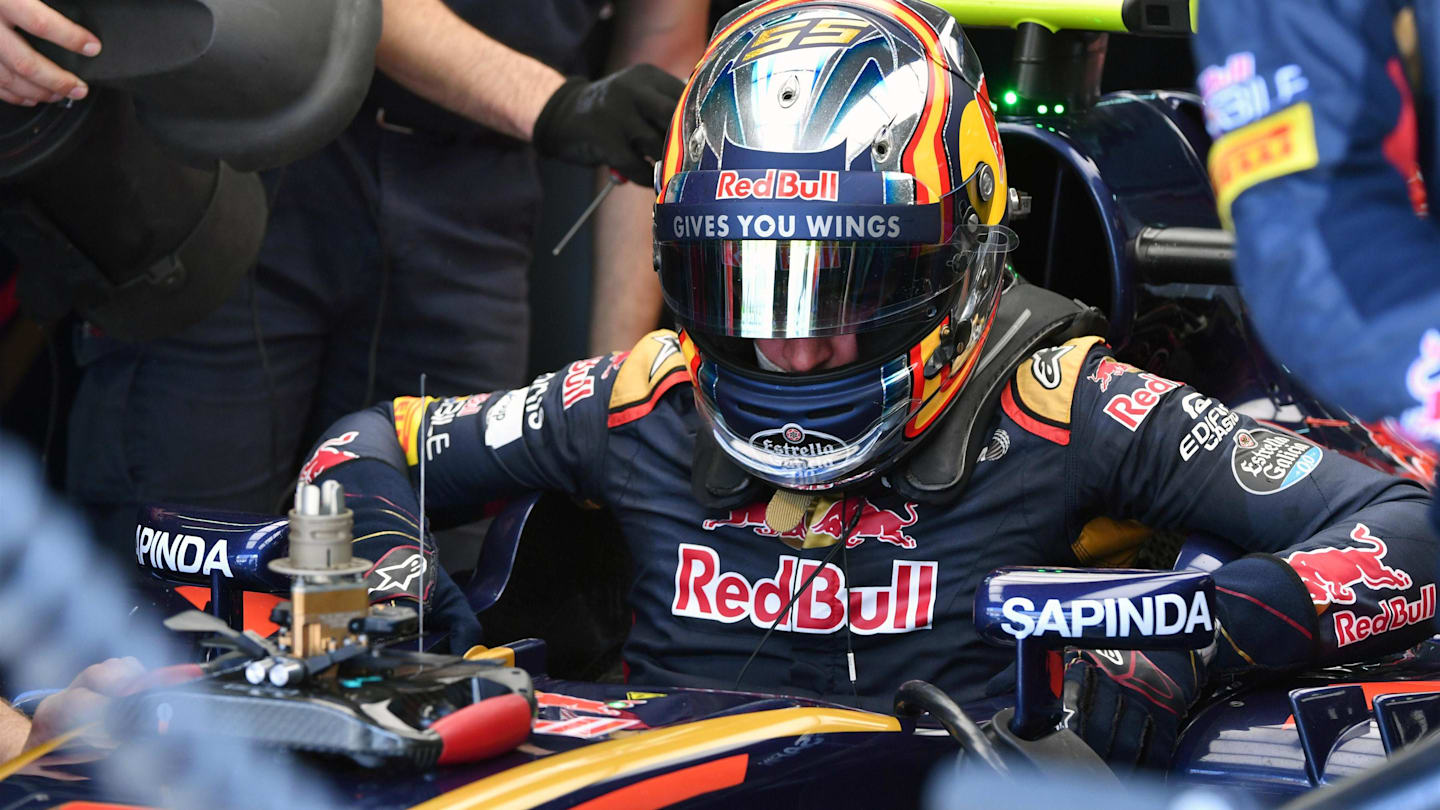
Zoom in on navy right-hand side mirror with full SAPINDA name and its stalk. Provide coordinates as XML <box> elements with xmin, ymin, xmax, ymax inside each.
<box><xmin>975</xmin><ymin>566</ymin><xmax>1215</xmax><ymax>739</ymax></box>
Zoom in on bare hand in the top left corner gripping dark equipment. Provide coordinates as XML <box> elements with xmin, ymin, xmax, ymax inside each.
<box><xmin>0</xmin><ymin>0</ymin><xmax>99</xmax><ymax>107</ymax></box>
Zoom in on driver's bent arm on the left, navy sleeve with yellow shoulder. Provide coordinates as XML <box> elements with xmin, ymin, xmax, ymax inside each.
<box><xmin>300</xmin><ymin>331</ymin><xmax>690</xmax><ymax>616</ymax></box>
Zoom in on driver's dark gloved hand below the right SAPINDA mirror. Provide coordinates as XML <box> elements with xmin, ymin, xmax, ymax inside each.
<box><xmin>1064</xmin><ymin>650</ymin><xmax>1205</xmax><ymax>768</ymax></box>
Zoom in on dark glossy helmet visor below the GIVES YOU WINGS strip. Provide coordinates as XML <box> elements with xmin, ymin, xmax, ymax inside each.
<box><xmin>657</xmin><ymin>228</ymin><xmax>1009</xmax><ymax>339</ymax></box>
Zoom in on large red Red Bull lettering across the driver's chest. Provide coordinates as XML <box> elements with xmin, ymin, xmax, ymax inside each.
<box><xmin>670</xmin><ymin>543</ymin><xmax>940</xmax><ymax>636</ymax></box>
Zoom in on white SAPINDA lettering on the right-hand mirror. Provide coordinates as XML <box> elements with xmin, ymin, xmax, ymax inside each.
<box><xmin>999</xmin><ymin>591</ymin><xmax>1215</xmax><ymax>638</ymax></box>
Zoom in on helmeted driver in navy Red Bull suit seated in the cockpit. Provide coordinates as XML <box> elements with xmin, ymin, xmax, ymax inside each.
<box><xmin>302</xmin><ymin>0</ymin><xmax>1437</xmax><ymax>765</ymax></box>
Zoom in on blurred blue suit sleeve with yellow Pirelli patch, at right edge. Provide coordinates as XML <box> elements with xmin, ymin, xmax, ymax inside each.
<box><xmin>1195</xmin><ymin>0</ymin><xmax>1440</xmax><ymax>441</ymax></box>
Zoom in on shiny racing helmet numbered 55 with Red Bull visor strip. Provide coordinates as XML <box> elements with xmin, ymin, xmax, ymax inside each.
<box><xmin>655</xmin><ymin>0</ymin><xmax>1014</xmax><ymax>490</ymax></box>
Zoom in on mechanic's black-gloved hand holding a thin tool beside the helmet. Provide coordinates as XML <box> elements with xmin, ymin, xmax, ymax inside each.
<box><xmin>533</xmin><ymin>65</ymin><xmax>685</xmax><ymax>187</ymax></box>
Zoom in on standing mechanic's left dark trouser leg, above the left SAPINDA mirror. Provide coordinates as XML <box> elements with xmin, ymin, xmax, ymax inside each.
<box><xmin>68</xmin><ymin>150</ymin><xmax>373</xmax><ymax>559</ymax></box>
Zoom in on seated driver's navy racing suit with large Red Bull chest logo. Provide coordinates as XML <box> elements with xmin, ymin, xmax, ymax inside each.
<box><xmin>302</xmin><ymin>331</ymin><xmax>1440</xmax><ymax>700</ymax></box>
